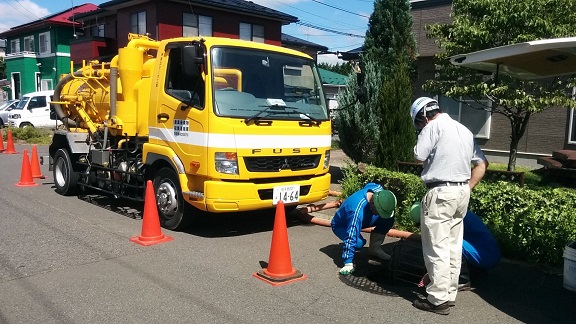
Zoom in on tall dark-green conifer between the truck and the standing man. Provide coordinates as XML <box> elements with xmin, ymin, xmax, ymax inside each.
<box><xmin>336</xmin><ymin>0</ymin><xmax>416</xmax><ymax>168</ymax></box>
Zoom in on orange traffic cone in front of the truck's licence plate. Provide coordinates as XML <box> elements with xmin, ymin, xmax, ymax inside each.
<box><xmin>252</xmin><ymin>201</ymin><xmax>306</xmax><ymax>286</ymax></box>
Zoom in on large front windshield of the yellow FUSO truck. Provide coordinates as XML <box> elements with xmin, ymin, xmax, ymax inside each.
<box><xmin>212</xmin><ymin>47</ymin><xmax>328</xmax><ymax>121</ymax></box>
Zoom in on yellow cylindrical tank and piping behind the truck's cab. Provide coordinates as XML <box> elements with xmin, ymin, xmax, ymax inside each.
<box><xmin>53</xmin><ymin>34</ymin><xmax>158</xmax><ymax>136</ymax></box>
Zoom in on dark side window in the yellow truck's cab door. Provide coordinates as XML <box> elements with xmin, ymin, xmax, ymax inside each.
<box><xmin>165</xmin><ymin>47</ymin><xmax>205</xmax><ymax>109</ymax></box>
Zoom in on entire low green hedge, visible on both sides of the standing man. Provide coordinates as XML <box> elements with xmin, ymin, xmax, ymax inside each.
<box><xmin>342</xmin><ymin>165</ymin><xmax>576</xmax><ymax>264</ymax></box>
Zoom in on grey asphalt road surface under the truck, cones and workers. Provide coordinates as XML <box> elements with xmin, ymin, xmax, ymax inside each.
<box><xmin>0</xmin><ymin>145</ymin><xmax>576</xmax><ymax>324</ymax></box>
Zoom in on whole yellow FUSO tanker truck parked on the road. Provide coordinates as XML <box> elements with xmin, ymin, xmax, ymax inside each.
<box><xmin>49</xmin><ymin>34</ymin><xmax>331</xmax><ymax>229</ymax></box>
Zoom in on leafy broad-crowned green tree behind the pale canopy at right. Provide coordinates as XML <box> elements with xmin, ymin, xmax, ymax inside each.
<box><xmin>424</xmin><ymin>0</ymin><xmax>576</xmax><ymax>171</ymax></box>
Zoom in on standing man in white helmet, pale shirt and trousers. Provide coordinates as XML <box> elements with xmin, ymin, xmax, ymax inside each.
<box><xmin>410</xmin><ymin>97</ymin><xmax>488</xmax><ymax>315</ymax></box>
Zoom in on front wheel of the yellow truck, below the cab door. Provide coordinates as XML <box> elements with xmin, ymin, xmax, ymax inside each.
<box><xmin>153</xmin><ymin>168</ymin><xmax>192</xmax><ymax>230</ymax></box>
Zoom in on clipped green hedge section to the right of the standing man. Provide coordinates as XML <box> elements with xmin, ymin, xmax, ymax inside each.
<box><xmin>470</xmin><ymin>182</ymin><xmax>576</xmax><ymax>264</ymax></box>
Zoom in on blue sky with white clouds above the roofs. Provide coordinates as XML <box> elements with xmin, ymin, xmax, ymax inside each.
<box><xmin>0</xmin><ymin>0</ymin><xmax>374</xmax><ymax>62</ymax></box>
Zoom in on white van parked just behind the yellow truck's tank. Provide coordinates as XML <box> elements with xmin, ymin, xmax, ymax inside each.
<box><xmin>8</xmin><ymin>90</ymin><xmax>61</xmax><ymax>128</ymax></box>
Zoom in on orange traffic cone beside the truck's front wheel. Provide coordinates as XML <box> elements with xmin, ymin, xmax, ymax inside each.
<box><xmin>130</xmin><ymin>180</ymin><xmax>173</xmax><ymax>246</ymax></box>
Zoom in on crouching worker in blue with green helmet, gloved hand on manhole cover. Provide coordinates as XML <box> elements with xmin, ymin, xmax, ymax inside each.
<box><xmin>331</xmin><ymin>182</ymin><xmax>396</xmax><ymax>275</ymax></box>
